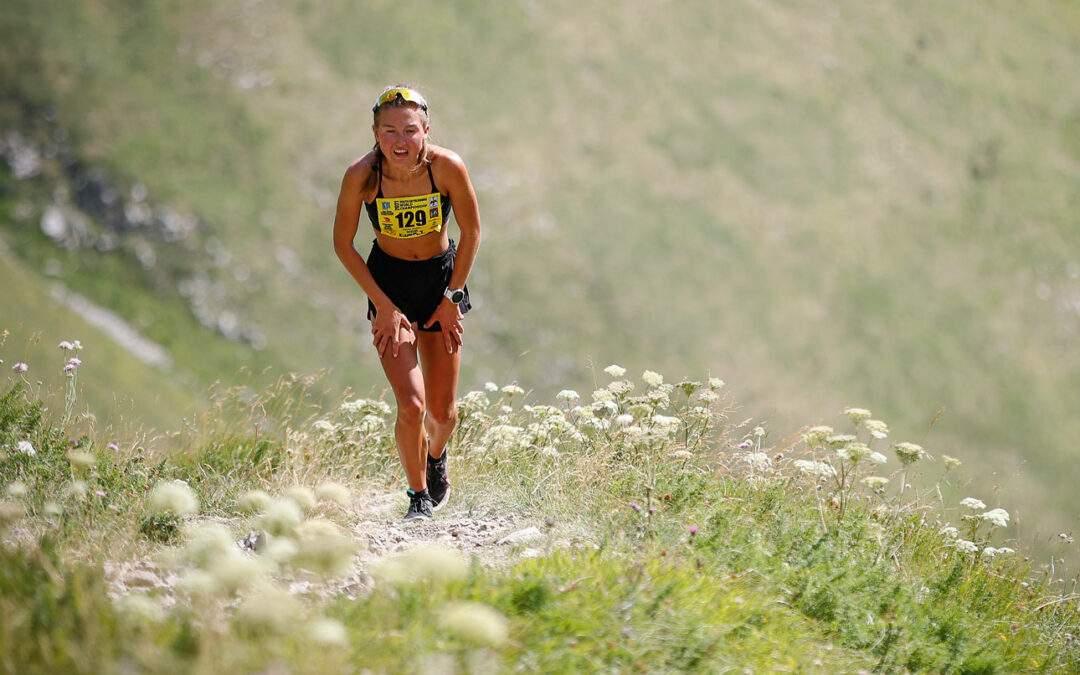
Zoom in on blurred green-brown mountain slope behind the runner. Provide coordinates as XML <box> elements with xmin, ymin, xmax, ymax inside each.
<box><xmin>0</xmin><ymin>0</ymin><xmax>1080</xmax><ymax>538</ymax></box>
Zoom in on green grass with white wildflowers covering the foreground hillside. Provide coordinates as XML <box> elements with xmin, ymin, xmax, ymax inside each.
<box><xmin>0</xmin><ymin>365</ymin><xmax>1080</xmax><ymax>674</ymax></box>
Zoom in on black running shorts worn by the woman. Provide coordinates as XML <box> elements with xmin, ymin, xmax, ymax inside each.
<box><xmin>367</xmin><ymin>239</ymin><xmax>472</xmax><ymax>333</ymax></box>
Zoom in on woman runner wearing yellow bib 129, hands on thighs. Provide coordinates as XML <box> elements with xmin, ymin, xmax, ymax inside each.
<box><xmin>334</xmin><ymin>86</ymin><xmax>481</xmax><ymax>521</ymax></box>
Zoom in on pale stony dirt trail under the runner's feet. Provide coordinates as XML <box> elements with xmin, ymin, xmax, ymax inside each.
<box><xmin>105</xmin><ymin>492</ymin><xmax>546</xmax><ymax>605</ymax></box>
